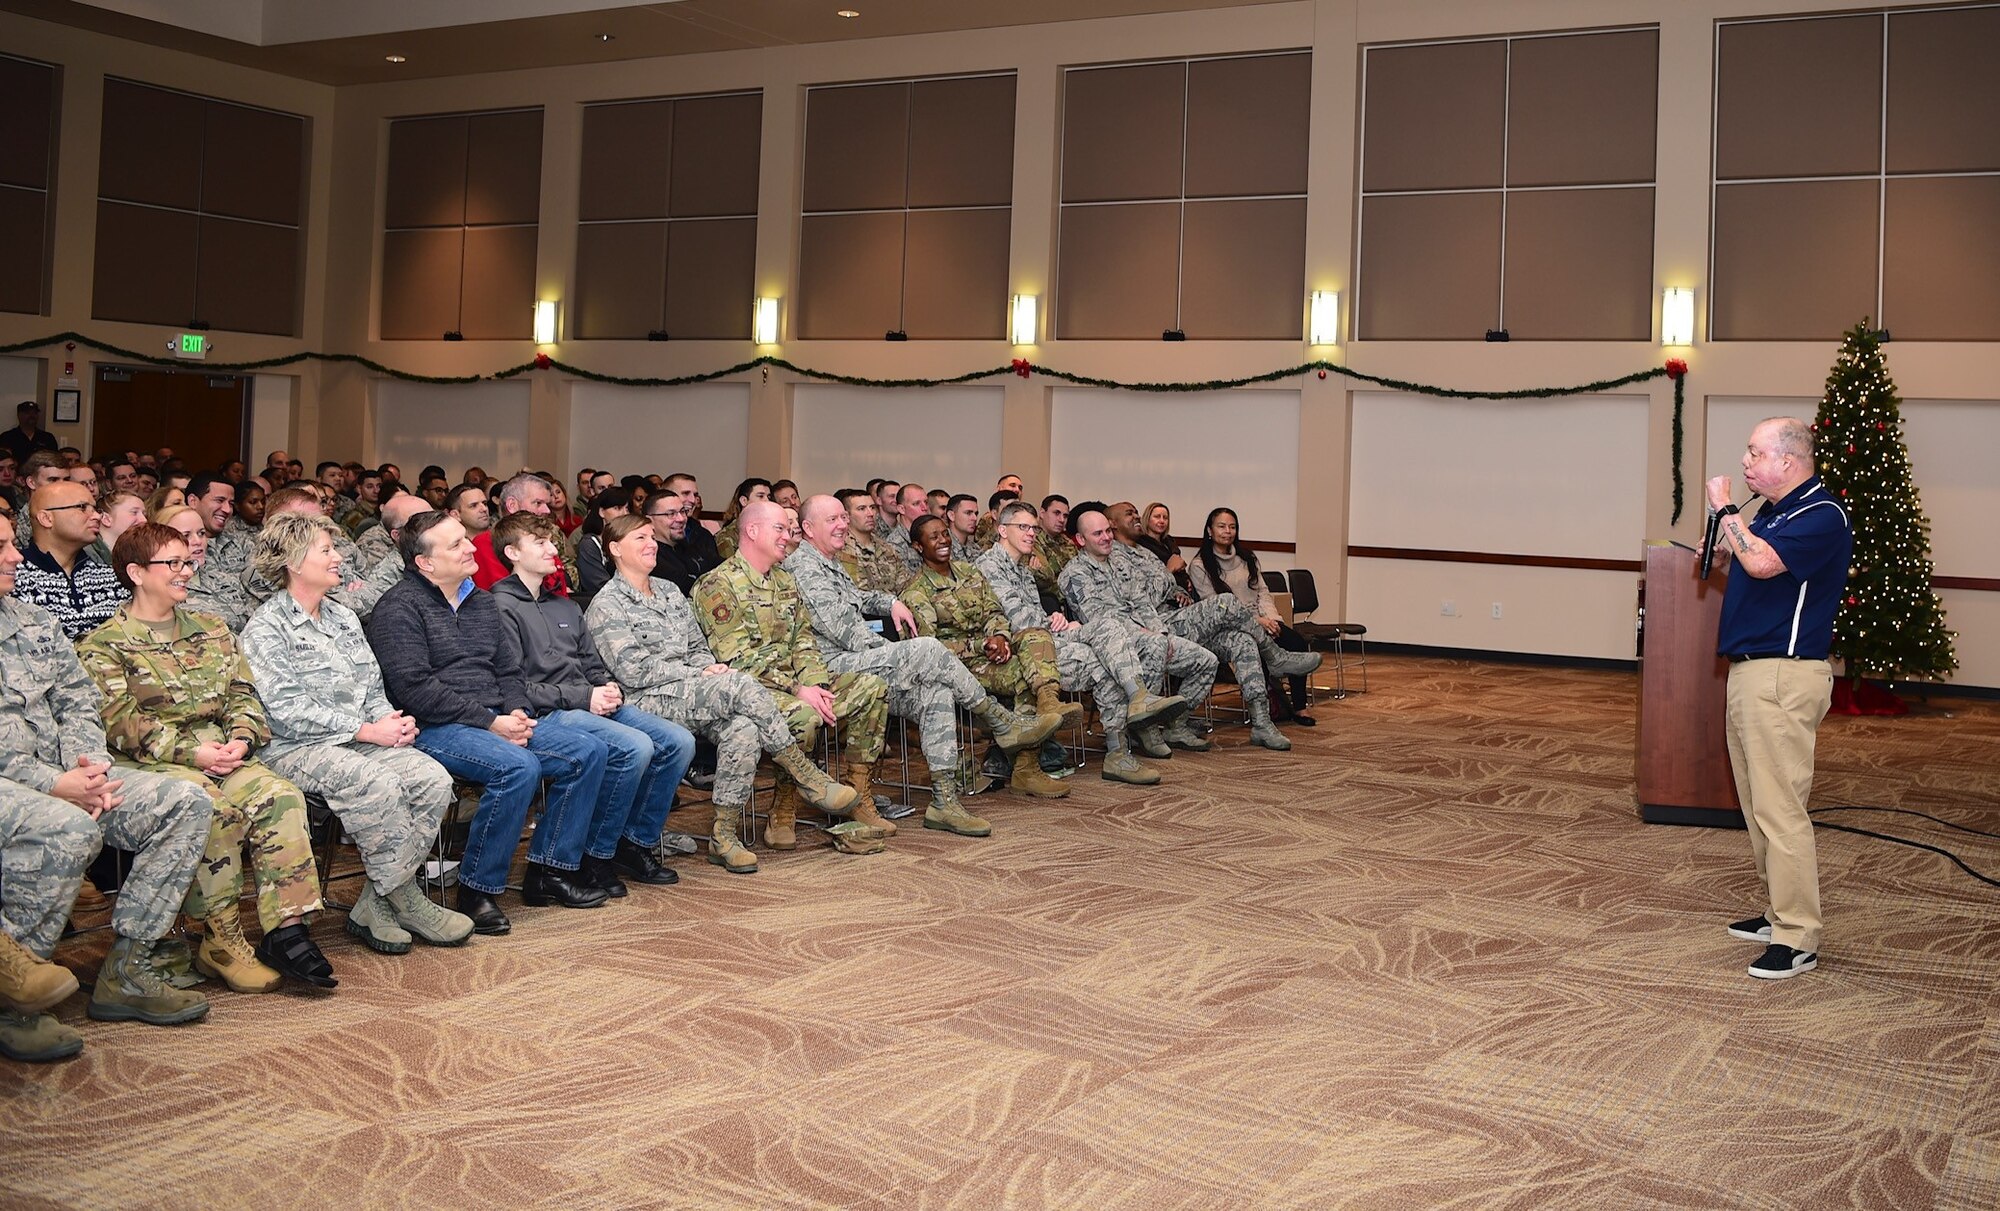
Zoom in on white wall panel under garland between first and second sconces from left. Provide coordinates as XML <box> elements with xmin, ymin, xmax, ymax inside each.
<box><xmin>564</xmin><ymin>382</ymin><xmax>750</xmax><ymax>491</ymax></box>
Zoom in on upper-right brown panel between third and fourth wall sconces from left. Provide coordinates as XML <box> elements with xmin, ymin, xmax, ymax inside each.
<box><xmin>1188</xmin><ymin>54</ymin><xmax>1312</xmax><ymax>198</ymax></box>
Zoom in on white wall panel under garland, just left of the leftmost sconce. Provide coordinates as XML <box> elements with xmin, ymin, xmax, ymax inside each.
<box><xmin>370</xmin><ymin>378</ymin><xmax>528</xmax><ymax>482</ymax></box>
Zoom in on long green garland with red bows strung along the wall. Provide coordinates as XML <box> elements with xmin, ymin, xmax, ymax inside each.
<box><xmin>0</xmin><ymin>332</ymin><xmax>1688</xmax><ymax>522</ymax></box>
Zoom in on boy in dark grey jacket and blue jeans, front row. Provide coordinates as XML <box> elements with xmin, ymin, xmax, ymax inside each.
<box><xmin>490</xmin><ymin>512</ymin><xmax>694</xmax><ymax>895</ymax></box>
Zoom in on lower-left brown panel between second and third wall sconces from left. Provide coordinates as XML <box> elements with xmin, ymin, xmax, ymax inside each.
<box><xmin>798</xmin><ymin>210</ymin><xmax>902</xmax><ymax>340</ymax></box>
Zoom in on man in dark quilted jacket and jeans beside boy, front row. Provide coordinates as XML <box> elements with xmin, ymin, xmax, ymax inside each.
<box><xmin>368</xmin><ymin>512</ymin><xmax>608</xmax><ymax>933</ymax></box>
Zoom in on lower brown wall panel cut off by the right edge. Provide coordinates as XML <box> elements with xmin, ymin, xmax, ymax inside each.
<box><xmin>1882</xmin><ymin>176</ymin><xmax>2000</xmax><ymax>340</ymax></box>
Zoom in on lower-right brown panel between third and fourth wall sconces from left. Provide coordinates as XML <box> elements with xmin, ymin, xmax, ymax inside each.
<box><xmin>1180</xmin><ymin>198</ymin><xmax>1306</xmax><ymax>340</ymax></box>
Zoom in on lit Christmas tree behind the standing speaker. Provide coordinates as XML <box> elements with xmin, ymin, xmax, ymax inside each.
<box><xmin>1812</xmin><ymin>320</ymin><xmax>1958</xmax><ymax>681</ymax></box>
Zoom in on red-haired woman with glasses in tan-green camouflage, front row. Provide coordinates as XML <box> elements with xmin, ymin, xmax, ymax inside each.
<box><xmin>76</xmin><ymin>524</ymin><xmax>338</xmax><ymax>991</ymax></box>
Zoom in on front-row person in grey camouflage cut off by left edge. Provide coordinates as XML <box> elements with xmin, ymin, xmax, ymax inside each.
<box><xmin>0</xmin><ymin>520</ymin><xmax>214</xmax><ymax>1063</ymax></box>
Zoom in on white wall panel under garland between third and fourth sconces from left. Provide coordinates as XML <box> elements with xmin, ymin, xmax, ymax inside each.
<box><xmin>1028</xmin><ymin>388</ymin><xmax>1298</xmax><ymax>570</ymax></box>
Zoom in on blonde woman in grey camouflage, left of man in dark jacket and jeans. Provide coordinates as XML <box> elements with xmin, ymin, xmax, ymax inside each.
<box><xmin>242</xmin><ymin>514</ymin><xmax>472</xmax><ymax>955</ymax></box>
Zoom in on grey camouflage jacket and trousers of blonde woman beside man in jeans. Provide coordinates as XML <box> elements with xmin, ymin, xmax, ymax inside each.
<box><xmin>242</xmin><ymin>594</ymin><xmax>452</xmax><ymax>895</ymax></box>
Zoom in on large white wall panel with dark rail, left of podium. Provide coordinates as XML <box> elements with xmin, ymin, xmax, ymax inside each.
<box><xmin>1346</xmin><ymin>392</ymin><xmax>1648</xmax><ymax>659</ymax></box>
